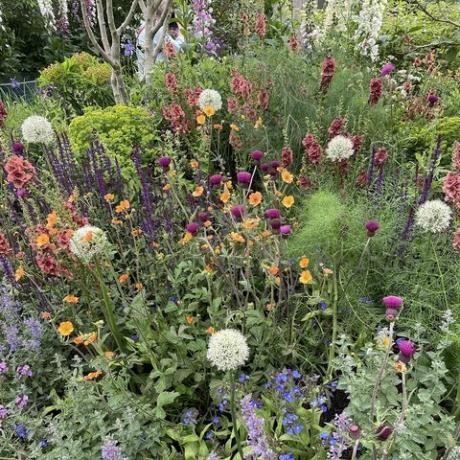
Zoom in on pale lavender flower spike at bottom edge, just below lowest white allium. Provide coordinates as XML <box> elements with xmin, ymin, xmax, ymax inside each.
<box><xmin>240</xmin><ymin>395</ymin><xmax>276</xmax><ymax>460</ymax></box>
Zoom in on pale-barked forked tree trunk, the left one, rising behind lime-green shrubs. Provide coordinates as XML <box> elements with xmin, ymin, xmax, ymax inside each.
<box><xmin>80</xmin><ymin>0</ymin><xmax>139</xmax><ymax>105</ymax></box>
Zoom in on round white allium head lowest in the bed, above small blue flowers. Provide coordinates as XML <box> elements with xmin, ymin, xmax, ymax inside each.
<box><xmin>208</xmin><ymin>329</ymin><xmax>249</xmax><ymax>371</ymax></box>
